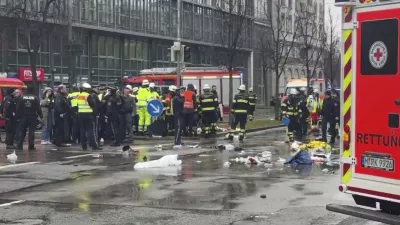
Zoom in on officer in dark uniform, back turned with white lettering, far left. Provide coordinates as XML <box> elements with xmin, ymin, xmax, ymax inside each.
<box><xmin>16</xmin><ymin>87</ymin><xmax>43</xmax><ymax>150</ymax></box>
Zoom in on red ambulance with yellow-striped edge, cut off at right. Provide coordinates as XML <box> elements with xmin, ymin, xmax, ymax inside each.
<box><xmin>327</xmin><ymin>0</ymin><xmax>400</xmax><ymax>224</ymax></box>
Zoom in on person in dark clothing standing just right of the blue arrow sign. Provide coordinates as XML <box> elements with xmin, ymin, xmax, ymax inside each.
<box><xmin>171</xmin><ymin>86</ymin><xmax>184</xmax><ymax>149</ymax></box>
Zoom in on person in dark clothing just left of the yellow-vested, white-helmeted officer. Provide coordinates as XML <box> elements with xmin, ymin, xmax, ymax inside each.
<box><xmin>53</xmin><ymin>85</ymin><xmax>70</xmax><ymax>147</ymax></box>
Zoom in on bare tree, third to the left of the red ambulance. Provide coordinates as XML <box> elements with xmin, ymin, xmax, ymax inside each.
<box><xmin>260</xmin><ymin>0</ymin><xmax>298</xmax><ymax>120</ymax></box>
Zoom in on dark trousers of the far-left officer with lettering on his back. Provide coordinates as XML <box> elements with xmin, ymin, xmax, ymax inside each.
<box><xmin>17</xmin><ymin>116</ymin><xmax>37</xmax><ymax>148</ymax></box>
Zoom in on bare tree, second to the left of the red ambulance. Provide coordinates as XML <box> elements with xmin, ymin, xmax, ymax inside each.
<box><xmin>296</xmin><ymin>0</ymin><xmax>326</xmax><ymax>91</ymax></box>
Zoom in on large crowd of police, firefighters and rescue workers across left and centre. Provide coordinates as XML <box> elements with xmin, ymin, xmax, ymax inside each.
<box><xmin>1</xmin><ymin>80</ymin><xmax>256</xmax><ymax>150</ymax></box>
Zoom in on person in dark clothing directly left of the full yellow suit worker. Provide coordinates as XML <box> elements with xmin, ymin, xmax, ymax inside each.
<box><xmin>122</xmin><ymin>85</ymin><xmax>136</xmax><ymax>143</ymax></box>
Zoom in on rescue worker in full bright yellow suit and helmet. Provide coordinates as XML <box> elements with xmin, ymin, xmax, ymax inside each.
<box><xmin>136</xmin><ymin>80</ymin><xmax>151</xmax><ymax>135</ymax></box>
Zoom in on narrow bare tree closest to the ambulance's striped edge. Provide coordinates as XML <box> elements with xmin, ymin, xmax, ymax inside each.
<box><xmin>323</xmin><ymin>9</ymin><xmax>340</xmax><ymax>88</ymax></box>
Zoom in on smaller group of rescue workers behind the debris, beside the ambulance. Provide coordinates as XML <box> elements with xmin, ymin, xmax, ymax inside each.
<box><xmin>281</xmin><ymin>87</ymin><xmax>340</xmax><ymax>144</ymax></box>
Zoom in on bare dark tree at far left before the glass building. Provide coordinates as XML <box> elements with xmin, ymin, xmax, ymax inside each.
<box><xmin>5</xmin><ymin>0</ymin><xmax>68</xmax><ymax>94</ymax></box>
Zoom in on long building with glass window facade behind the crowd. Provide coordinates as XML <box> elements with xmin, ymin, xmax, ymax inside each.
<box><xmin>0</xmin><ymin>0</ymin><xmax>253</xmax><ymax>89</ymax></box>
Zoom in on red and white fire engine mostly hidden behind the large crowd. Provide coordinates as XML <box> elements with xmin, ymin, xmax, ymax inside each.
<box><xmin>122</xmin><ymin>67</ymin><xmax>243</xmax><ymax>111</ymax></box>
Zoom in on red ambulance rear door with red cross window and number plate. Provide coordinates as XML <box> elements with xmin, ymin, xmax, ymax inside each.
<box><xmin>352</xmin><ymin>3</ymin><xmax>400</xmax><ymax>202</ymax></box>
